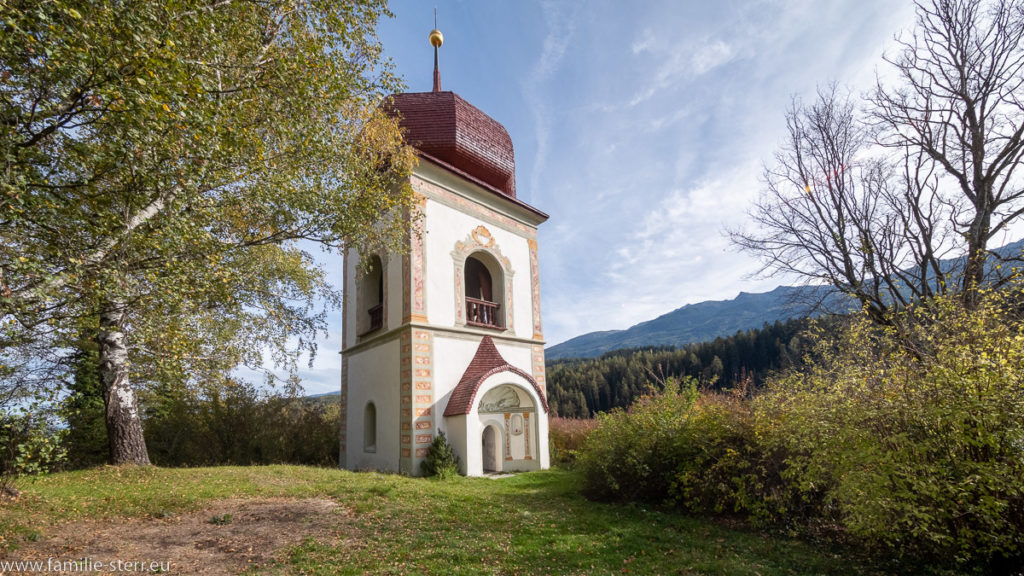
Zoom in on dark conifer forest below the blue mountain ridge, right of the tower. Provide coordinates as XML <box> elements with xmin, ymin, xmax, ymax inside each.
<box><xmin>548</xmin><ymin>319</ymin><xmax>810</xmax><ymax>418</ymax></box>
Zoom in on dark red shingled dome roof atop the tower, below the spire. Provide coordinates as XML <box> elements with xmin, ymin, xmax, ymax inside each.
<box><xmin>385</xmin><ymin>92</ymin><xmax>515</xmax><ymax>198</ymax></box>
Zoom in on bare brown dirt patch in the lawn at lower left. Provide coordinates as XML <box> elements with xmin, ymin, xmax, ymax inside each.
<box><xmin>0</xmin><ymin>498</ymin><xmax>351</xmax><ymax>575</ymax></box>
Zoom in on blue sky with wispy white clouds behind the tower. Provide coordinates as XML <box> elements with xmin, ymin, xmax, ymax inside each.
<box><xmin>290</xmin><ymin>0</ymin><xmax>913</xmax><ymax>394</ymax></box>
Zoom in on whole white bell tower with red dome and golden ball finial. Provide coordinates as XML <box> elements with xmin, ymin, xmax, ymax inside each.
<box><xmin>340</xmin><ymin>24</ymin><xmax>549</xmax><ymax>476</ymax></box>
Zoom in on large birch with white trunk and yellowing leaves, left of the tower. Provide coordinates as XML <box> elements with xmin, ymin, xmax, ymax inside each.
<box><xmin>0</xmin><ymin>0</ymin><xmax>414</xmax><ymax>464</ymax></box>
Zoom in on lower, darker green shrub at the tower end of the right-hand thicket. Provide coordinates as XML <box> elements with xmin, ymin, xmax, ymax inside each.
<box><xmin>578</xmin><ymin>379</ymin><xmax>781</xmax><ymax>517</ymax></box>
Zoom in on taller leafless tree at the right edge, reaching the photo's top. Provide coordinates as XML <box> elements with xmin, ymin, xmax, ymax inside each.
<box><xmin>870</xmin><ymin>0</ymin><xmax>1024</xmax><ymax>306</ymax></box>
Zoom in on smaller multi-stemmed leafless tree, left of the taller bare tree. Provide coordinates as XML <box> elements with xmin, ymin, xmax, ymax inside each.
<box><xmin>731</xmin><ymin>85</ymin><xmax>948</xmax><ymax>321</ymax></box>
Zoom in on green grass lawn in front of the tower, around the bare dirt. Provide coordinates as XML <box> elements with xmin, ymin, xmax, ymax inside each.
<box><xmin>0</xmin><ymin>466</ymin><xmax>878</xmax><ymax>576</ymax></box>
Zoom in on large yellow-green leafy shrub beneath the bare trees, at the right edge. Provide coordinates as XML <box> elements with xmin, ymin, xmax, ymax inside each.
<box><xmin>755</xmin><ymin>296</ymin><xmax>1024</xmax><ymax>571</ymax></box>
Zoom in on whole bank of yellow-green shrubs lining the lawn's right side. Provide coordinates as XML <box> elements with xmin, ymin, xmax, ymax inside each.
<box><xmin>578</xmin><ymin>294</ymin><xmax>1024</xmax><ymax>573</ymax></box>
